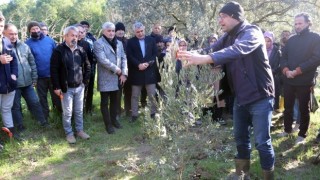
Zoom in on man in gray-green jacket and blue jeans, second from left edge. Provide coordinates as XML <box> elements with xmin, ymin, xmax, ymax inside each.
<box><xmin>4</xmin><ymin>24</ymin><xmax>48</xmax><ymax>131</ymax></box>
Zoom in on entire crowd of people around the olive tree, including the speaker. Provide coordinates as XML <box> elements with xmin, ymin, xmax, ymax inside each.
<box><xmin>0</xmin><ymin>2</ymin><xmax>320</xmax><ymax>179</ymax></box>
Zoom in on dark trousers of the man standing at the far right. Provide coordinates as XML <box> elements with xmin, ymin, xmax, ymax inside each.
<box><xmin>283</xmin><ymin>84</ymin><xmax>311</xmax><ymax>138</ymax></box>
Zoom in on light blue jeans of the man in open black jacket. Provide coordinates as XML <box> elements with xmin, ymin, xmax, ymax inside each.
<box><xmin>61</xmin><ymin>84</ymin><xmax>84</xmax><ymax>136</ymax></box>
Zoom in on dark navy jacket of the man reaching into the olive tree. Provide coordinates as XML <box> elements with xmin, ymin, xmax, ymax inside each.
<box><xmin>210</xmin><ymin>22</ymin><xmax>274</xmax><ymax>105</ymax></box>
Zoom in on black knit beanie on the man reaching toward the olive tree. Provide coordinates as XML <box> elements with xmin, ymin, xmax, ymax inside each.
<box><xmin>219</xmin><ymin>1</ymin><xmax>245</xmax><ymax>22</ymax></box>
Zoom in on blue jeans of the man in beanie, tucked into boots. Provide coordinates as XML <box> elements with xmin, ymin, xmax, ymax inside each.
<box><xmin>233</xmin><ymin>97</ymin><xmax>275</xmax><ymax>170</ymax></box>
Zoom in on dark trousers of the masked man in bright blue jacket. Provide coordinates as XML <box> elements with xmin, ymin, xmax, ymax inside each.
<box><xmin>37</xmin><ymin>77</ymin><xmax>62</xmax><ymax>120</ymax></box>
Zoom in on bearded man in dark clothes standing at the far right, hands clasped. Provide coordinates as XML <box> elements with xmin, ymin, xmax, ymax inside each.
<box><xmin>280</xmin><ymin>13</ymin><xmax>320</xmax><ymax>144</ymax></box>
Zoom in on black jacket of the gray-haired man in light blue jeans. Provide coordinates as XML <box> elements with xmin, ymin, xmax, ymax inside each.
<box><xmin>50</xmin><ymin>43</ymin><xmax>91</xmax><ymax>93</ymax></box>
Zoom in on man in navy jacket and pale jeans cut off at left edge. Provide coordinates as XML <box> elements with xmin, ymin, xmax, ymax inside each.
<box><xmin>0</xmin><ymin>11</ymin><xmax>18</xmax><ymax>140</ymax></box>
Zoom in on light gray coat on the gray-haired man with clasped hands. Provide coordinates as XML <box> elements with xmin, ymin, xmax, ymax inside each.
<box><xmin>93</xmin><ymin>37</ymin><xmax>128</xmax><ymax>92</ymax></box>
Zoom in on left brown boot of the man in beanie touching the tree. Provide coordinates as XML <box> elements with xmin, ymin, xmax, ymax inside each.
<box><xmin>234</xmin><ymin>159</ymin><xmax>250</xmax><ymax>180</ymax></box>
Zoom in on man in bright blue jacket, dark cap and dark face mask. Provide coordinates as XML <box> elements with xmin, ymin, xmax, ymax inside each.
<box><xmin>26</xmin><ymin>21</ymin><xmax>62</xmax><ymax>122</ymax></box>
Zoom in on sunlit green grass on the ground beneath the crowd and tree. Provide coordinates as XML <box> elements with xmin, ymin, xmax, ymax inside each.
<box><xmin>0</xmin><ymin>88</ymin><xmax>320</xmax><ymax>180</ymax></box>
